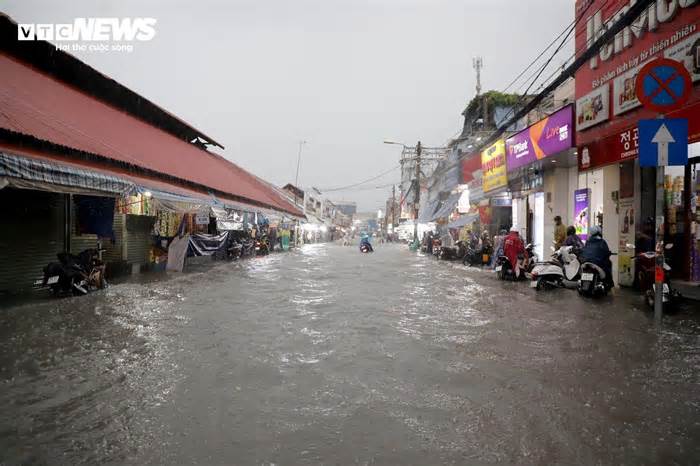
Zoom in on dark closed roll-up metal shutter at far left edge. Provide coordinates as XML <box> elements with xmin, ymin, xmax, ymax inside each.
<box><xmin>0</xmin><ymin>188</ymin><xmax>66</xmax><ymax>295</ymax></box>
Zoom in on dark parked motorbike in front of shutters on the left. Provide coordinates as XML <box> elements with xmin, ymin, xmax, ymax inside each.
<box><xmin>34</xmin><ymin>247</ymin><xmax>107</xmax><ymax>296</ymax></box>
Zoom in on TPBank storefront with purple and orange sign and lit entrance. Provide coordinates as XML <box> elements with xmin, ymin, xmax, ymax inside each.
<box><xmin>506</xmin><ymin>105</ymin><xmax>577</xmax><ymax>258</ymax></box>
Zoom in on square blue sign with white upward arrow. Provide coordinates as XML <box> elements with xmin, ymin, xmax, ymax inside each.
<box><xmin>639</xmin><ymin>118</ymin><xmax>688</xmax><ymax>167</ymax></box>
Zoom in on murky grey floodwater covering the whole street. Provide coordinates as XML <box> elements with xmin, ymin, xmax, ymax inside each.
<box><xmin>0</xmin><ymin>244</ymin><xmax>700</xmax><ymax>465</ymax></box>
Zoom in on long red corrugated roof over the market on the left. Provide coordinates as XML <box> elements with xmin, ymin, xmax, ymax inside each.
<box><xmin>0</xmin><ymin>54</ymin><xmax>302</xmax><ymax>215</ymax></box>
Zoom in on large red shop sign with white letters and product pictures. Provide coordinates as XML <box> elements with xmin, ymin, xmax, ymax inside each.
<box><xmin>575</xmin><ymin>0</ymin><xmax>700</xmax><ymax>162</ymax></box>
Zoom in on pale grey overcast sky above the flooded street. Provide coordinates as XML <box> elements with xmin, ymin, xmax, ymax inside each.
<box><xmin>2</xmin><ymin>0</ymin><xmax>574</xmax><ymax>210</ymax></box>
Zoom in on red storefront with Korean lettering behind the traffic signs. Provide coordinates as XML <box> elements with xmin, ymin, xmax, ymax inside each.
<box><xmin>576</xmin><ymin>0</ymin><xmax>700</xmax><ymax>286</ymax></box>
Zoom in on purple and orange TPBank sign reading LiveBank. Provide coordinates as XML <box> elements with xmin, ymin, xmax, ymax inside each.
<box><xmin>506</xmin><ymin>105</ymin><xmax>574</xmax><ymax>171</ymax></box>
